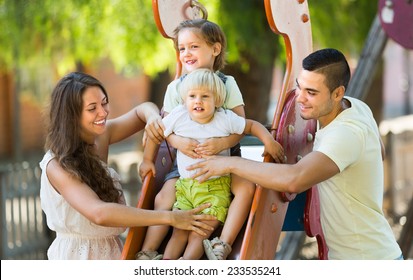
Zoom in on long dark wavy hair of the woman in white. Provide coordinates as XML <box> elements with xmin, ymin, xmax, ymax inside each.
<box><xmin>45</xmin><ymin>72</ymin><xmax>122</xmax><ymax>202</ymax></box>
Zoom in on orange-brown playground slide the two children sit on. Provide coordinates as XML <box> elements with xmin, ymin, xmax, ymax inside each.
<box><xmin>122</xmin><ymin>0</ymin><xmax>327</xmax><ymax>260</ymax></box>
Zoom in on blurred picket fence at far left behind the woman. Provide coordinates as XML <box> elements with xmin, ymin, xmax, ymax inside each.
<box><xmin>0</xmin><ymin>162</ymin><xmax>53</xmax><ymax>260</ymax></box>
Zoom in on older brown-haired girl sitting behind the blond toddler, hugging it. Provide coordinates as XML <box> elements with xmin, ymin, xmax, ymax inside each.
<box><xmin>136</xmin><ymin>19</ymin><xmax>283</xmax><ymax>260</ymax></box>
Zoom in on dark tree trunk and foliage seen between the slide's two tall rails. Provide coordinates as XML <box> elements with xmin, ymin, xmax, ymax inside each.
<box><xmin>218</xmin><ymin>1</ymin><xmax>284</xmax><ymax>123</ymax></box>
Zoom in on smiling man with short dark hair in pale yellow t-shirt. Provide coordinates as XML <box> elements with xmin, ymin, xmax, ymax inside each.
<box><xmin>189</xmin><ymin>49</ymin><xmax>403</xmax><ymax>259</ymax></box>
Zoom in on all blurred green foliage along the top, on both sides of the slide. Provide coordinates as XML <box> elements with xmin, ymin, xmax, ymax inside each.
<box><xmin>0</xmin><ymin>0</ymin><xmax>377</xmax><ymax>75</ymax></box>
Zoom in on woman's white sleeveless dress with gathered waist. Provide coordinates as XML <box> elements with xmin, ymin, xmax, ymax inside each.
<box><xmin>40</xmin><ymin>151</ymin><xmax>126</xmax><ymax>260</ymax></box>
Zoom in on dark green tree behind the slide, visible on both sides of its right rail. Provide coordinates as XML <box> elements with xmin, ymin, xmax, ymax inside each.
<box><xmin>217</xmin><ymin>0</ymin><xmax>377</xmax><ymax>123</ymax></box>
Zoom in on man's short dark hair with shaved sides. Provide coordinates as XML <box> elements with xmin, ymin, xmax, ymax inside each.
<box><xmin>303</xmin><ymin>49</ymin><xmax>351</xmax><ymax>92</ymax></box>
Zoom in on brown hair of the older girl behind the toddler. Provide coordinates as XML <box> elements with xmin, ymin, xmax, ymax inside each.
<box><xmin>174</xmin><ymin>19</ymin><xmax>227</xmax><ymax>71</ymax></box>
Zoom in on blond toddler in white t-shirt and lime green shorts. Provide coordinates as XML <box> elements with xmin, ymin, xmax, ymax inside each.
<box><xmin>140</xmin><ymin>68</ymin><xmax>282</xmax><ymax>260</ymax></box>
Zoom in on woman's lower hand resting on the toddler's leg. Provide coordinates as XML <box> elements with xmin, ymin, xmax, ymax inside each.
<box><xmin>171</xmin><ymin>203</ymin><xmax>216</xmax><ymax>236</ymax></box>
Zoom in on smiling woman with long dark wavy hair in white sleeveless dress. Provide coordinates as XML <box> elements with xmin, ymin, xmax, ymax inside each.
<box><xmin>40</xmin><ymin>72</ymin><xmax>215</xmax><ymax>260</ymax></box>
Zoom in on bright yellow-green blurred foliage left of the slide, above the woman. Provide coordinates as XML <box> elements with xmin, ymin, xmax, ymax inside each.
<box><xmin>0</xmin><ymin>0</ymin><xmax>174</xmax><ymax>74</ymax></box>
